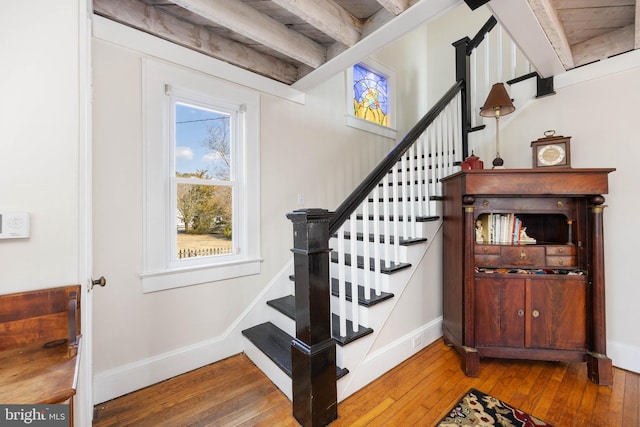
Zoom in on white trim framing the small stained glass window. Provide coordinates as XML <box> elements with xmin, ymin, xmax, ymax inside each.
<box><xmin>345</xmin><ymin>59</ymin><xmax>398</xmax><ymax>140</ymax></box>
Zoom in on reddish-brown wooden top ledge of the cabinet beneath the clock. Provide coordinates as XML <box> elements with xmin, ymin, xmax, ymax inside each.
<box><xmin>441</xmin><ymin>168</ymin><xmax>615</xmax><ymax>197</ymax></box>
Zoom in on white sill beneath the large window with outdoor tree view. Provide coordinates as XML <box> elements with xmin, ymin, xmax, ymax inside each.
<box><xmin>140</xmin><ymin>258</ymin><xmax>262</xmax><ymax>293</ymax></box>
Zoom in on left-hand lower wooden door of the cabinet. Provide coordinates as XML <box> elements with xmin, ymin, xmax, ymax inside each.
<box><xmin>474</xmin><ymin>274</ymin><xmax>525</xmax><ymax>347</ymax></box>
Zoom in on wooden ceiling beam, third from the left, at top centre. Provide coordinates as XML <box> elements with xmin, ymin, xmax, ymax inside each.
<box><xmin>272</xmin><ymin>0</ymin><xmax>362</xmax><ymax>47</ymax></box>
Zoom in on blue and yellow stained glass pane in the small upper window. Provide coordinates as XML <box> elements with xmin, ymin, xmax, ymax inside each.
<box><xmin>353</xmin><ymin>64</ymin><xmax>389</xmax><ymax>126</ymax></box>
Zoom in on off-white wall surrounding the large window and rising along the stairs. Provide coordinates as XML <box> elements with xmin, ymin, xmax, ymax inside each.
<box><xmin>93</xmin><ymin>17</ymin><xmax>436</xmax><ymax>402</ymax></box>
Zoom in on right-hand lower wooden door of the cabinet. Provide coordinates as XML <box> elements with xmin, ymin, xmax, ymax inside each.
<box><xmin>525</xmin><ymin>276</ymin><xmax>587</xmax><ymax>350</ymax></box>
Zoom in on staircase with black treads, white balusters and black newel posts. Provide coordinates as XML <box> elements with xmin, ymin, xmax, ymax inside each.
<box><xmin>242</xmin><ymin>14</ymin><xmax>530</xmax><ymax>425</ymax></box>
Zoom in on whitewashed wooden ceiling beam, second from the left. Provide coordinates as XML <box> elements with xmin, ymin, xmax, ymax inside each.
<box><xmin>171</xmin><ymin>0</ymin><xmax>327</xmax><ymax>68</ymax></box>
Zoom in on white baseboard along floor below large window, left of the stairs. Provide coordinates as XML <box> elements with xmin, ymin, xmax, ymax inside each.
<box><xmin>93</xmin><ymin>335</ymin><xmax>242</xmax><ymax>404</ymax></box>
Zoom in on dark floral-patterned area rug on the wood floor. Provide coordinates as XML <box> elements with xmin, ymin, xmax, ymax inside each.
<box><xmin>436</xmin><ymin>388</ymin><xmax>552</xmax><ymax>427</ymax></box>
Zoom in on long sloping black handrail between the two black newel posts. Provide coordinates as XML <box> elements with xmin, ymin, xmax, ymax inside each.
<box><xmin>329</xmin><ymin>80</ymin><xmax>464</xmax><ymax>235</ymax></box>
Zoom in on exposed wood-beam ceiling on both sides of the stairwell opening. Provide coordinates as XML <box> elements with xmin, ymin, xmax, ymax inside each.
<box><xmin>93</xmin><ymin>0</ymin><xmax>640</xmax><ymax>85</ymax></box>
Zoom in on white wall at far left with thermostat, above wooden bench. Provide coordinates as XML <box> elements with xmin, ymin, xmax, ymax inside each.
<box><xmin>0</xmin><ymin>0</ymin><xmax>79</xmax><ymax>294</ymax></box>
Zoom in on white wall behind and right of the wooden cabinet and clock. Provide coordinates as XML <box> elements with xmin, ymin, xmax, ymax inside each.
<box><xmin>501</xmin><ymin>61</ymin><xmax>640</xmax><ymax>372</ymax></box>
